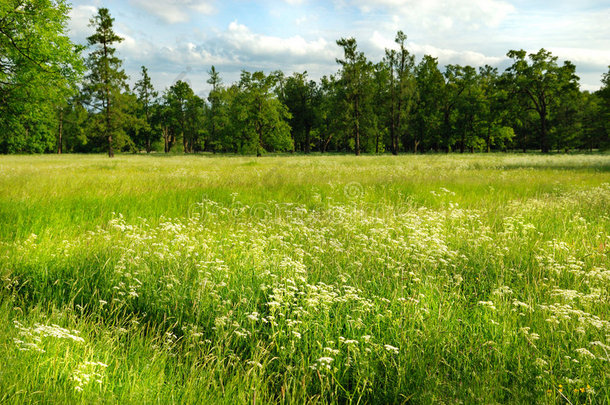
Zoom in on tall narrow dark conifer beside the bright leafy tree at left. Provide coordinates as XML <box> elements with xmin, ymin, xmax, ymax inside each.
<box><xmin>83</xmin><ymin>8</ymin><xmax>129</xmax><ymax>157</ymax></box>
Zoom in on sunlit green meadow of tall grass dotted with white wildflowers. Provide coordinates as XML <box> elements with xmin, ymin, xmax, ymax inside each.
<box><xmin>0</xmin><ymin>155</ymin><xmax>610</xmax><ymax>404</ymax></box>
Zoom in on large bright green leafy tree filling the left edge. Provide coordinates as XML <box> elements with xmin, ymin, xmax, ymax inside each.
<box><xmin>0</xmin><ymin>0</ymin><xmax>83</xmax><ymax>153</ymax></box>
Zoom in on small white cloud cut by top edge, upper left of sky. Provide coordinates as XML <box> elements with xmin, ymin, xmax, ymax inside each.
<box><xmin>130</xmin><ymin>0</ymin><xmax>215</xmax><ymax>24</ymax></box>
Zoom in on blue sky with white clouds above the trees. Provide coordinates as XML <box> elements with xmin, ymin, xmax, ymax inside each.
<box><xmin>70</xmin><ymin>0</ymin><xmax>610</xmax><ymax>94</ymax></box>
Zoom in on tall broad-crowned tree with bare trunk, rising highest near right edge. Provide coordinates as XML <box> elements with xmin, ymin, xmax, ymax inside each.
<box><xmin>507</xmin><ymin>49</ymin><xmax>578</xmax><ymax>153</ymax></box>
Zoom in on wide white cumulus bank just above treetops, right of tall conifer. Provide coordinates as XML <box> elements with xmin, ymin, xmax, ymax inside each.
<box><xmin>110</xmin><ymin>21</ymin><xmax>340</xmax><ymax>92</ymax></box>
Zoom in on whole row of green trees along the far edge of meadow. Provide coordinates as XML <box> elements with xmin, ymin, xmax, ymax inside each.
<box><xmin>0</xmin><ymin>0</ymin><xmax>610</xmax><ymax>156</ymax></box>
